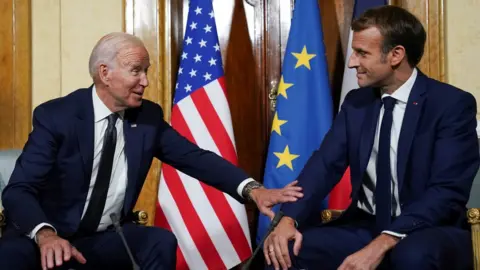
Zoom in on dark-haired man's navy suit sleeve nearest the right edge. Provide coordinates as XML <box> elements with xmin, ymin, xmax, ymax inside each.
<box><xmin>388</xmin><ymin>93</ymin><xmax>480</xmax><ymax>234</ymax></box>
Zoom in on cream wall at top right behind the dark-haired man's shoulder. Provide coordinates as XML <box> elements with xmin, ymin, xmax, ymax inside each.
<box><xmin>444</xmin><ymin>0</ymin><xmax>480</xmax><ymax>112</ymax></box>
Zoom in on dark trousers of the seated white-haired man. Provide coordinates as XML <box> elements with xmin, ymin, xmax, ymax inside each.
<box><xmin>0</xmin><ymin>223</ymin><xmax>177</xmax><ymax>270</ymax></box>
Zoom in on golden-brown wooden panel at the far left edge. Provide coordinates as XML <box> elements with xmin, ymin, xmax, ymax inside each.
<box><xmin>0</xmin><ymin>0</ymin><xmax>32</xmax><ymax>149</ymax></box>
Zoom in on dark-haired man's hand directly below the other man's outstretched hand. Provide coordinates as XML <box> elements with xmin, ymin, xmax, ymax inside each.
<box><xmin>263</xmin><ymin>217</ymin><xmax>302</xmax><ymax>270</ymax></box>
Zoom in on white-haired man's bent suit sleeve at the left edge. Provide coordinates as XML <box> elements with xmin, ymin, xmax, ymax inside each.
<box><xmin>2</xmin><ymin>106</ymin><xmax>57</xmax><ymax>234</ymax></box>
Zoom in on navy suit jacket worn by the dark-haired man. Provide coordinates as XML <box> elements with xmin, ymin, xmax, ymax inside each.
<box><xmin>282</xmin><ymin>72</ymin><xmax>479</xmax><ymax>233</ymax></box>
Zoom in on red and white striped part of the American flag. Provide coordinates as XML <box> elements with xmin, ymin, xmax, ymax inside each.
<box><xmin>156</xmin><ymin>77</ymin><xmax>251</xmax><ymax>269</ymax></box>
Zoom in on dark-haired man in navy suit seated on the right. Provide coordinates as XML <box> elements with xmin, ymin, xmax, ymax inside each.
<box><xmin>264</xmin><ymin>6</ymin><xmax>479</xmax><ymax>270</ymax></box>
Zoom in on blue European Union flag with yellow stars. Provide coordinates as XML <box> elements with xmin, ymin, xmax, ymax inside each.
<box><xmin>257</xmin><ymin>0</ymin><xmax>333</xmax><ymax>243</ymax></box>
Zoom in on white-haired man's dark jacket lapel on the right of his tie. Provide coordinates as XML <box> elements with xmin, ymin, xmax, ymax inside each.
<box><xmin>123</xmin><ymin>110</ymin><xmax>144</xmax><ymax>215</ymax></box>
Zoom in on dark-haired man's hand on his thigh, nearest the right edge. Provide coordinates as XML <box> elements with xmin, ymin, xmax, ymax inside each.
<box><xmin>338</xmin><ymin>234</ymin><xmax>400</xmax><ymax>270</ymax></box>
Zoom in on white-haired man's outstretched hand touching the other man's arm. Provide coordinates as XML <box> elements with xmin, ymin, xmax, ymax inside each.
<box><xmin>250</xmin><ymin>180</ymin><xmax>303</xmax><ymax>219</ymax></box>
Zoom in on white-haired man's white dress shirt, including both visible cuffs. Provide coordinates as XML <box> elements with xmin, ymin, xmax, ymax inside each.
<box><xmin>29</xmin><ymin>86</ymin><xmax>254</xmax><ymax>240</ymax></box>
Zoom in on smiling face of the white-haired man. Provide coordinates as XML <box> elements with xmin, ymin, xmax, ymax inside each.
<box><xmin>99</xmin><ymin>45</ymin><xmax>150</xmax><ymax>111</ymax></box>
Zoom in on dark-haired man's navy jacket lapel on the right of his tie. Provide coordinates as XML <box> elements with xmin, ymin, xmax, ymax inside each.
<box><xmin>397</xmin><ymin>71</ymin><xmax>427</xmax><ymax>191</ymax></box>
